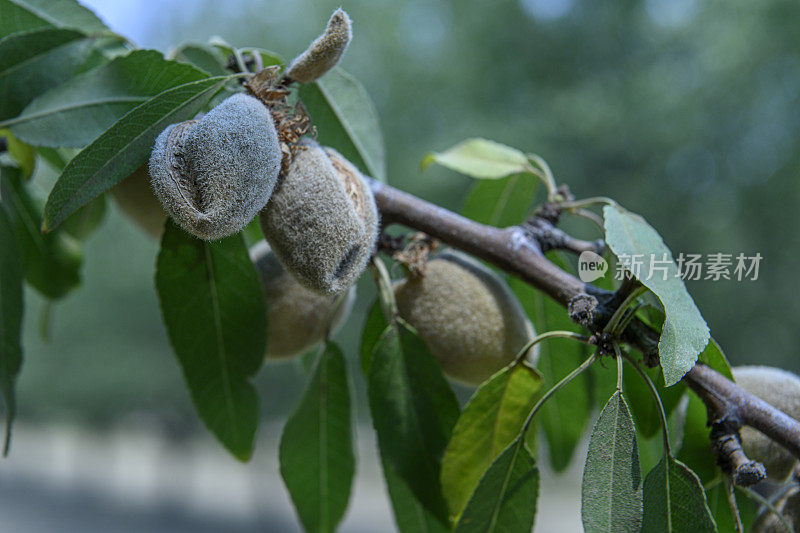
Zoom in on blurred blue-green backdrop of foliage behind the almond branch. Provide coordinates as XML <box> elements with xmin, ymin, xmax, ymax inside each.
<box><xmin>12</xmin><ymin>0</ymin><xmax>800</xmax><ymax>430</ymax></box>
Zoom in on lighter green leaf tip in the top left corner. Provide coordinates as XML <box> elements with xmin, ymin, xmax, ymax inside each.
<box><xmin>0</xmin><ymin>0</ymin><xmax>108</xmax><ymax>37</ymax></box>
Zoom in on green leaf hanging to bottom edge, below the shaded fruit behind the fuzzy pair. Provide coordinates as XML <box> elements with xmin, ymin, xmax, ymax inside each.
<box><xmin>280</xmin><ymin>344</ymin><xmax>355</xmax><ymax>532</ymax></box>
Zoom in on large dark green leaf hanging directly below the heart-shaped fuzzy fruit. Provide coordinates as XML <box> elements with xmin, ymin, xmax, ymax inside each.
<box><xmin>156</xmin><ymin>221</ymin><xmax>267</xmax><ymax>461</ymax></box>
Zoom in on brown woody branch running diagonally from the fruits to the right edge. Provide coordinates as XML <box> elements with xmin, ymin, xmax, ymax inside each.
<box><xmin>370</xmin><ymin>180</ymin><xmax>800</xmax><ymax>464</ymax></box>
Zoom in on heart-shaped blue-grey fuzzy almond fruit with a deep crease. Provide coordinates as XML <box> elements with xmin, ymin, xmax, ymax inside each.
<box><xmin>150</xmin><ymin>93</ymin><xmax>282</xmax><ymax>240</ymax></box>
